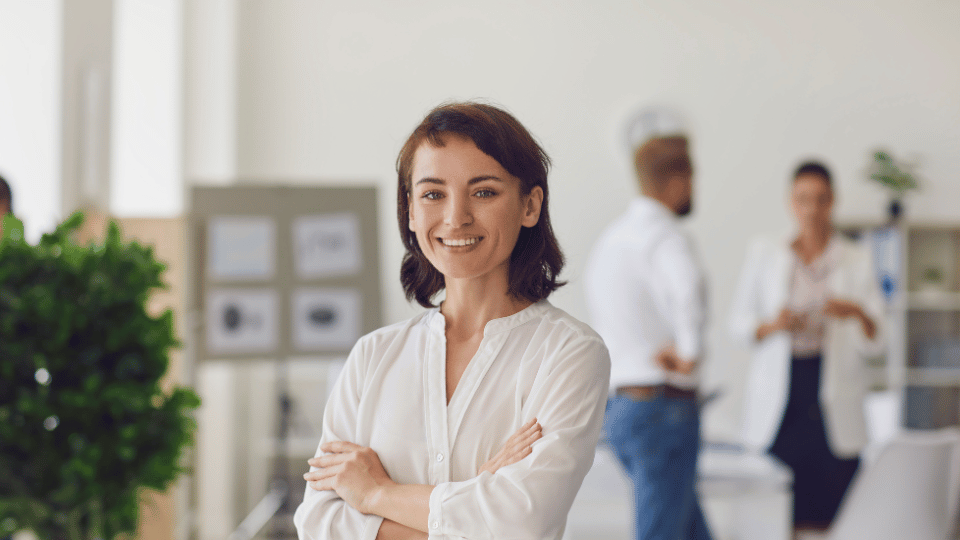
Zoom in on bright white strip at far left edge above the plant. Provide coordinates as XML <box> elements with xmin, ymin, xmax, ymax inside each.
<box><xmin>0</xmin><ymin>0</ymin><xmax>62</xmax><ymax>242</ymax></box>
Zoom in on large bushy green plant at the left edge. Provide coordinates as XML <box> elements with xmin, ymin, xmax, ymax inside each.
<box><xmin>0</xmin><ymin>213</ymin><xmax>199</xmax><ymax>540</ymax></box>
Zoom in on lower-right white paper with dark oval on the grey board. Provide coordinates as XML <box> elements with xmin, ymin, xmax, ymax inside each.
<box><xmin>291</xmin><ymin>288</ymin><xmax>363</xmax><ymax>352</ymax></box>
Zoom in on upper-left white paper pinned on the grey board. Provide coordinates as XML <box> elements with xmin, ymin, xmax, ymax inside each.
<box><xmin>207</xmin><ymin>216</ymin><xmax>277</xmax><ymax>280</ymax></box>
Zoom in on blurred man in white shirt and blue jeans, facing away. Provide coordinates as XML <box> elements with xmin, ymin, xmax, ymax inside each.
<box><xmin>585</xmin><ymin>109</ymin><xmax>710</xmax><ymax>540</ymax></box>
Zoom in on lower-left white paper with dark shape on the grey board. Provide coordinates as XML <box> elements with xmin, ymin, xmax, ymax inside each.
<box><xmin>205</xmin><ymin>289</ymin><xmax>280</xmax><ymax>354</ymax></box>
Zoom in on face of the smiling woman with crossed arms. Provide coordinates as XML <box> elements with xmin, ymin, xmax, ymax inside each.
<box><xmin>410</xmin><ymin>134</ymin><xmax>543</xmax><ymax>283</ymax></box>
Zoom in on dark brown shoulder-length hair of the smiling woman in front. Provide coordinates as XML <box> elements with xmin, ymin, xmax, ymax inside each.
<box><xmin>397</xmin><ymin>102</ymin><xmax>565</xmax><ymax>307</ymax></box>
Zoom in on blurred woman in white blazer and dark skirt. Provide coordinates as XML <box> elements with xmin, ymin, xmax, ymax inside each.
<box><xmin>731</xmin><ymin>162</ymin><xmax>883</xmax><ymax>529</ymax></box>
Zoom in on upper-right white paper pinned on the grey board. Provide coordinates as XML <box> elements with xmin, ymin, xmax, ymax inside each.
<box><xmin>293</xmin><ymin>213</ymin><xmax>363</xmax><ymax>279</ymax></box>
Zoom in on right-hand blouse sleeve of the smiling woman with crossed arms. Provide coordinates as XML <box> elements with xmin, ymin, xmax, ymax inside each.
<box><xmin>427</xmin><ymin>335</ymin><xmax>610</xmax><ymax>540</ymax></box>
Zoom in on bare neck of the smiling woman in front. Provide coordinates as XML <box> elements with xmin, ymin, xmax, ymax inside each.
<box><xmin>440</xmin><ymin>276</ymin><xmax>533</xmax><ymax>337</ymax></box>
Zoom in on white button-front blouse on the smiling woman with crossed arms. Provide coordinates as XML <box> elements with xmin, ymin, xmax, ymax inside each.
<box><xmin>294</xmin><ymin>300</ymin><xmax>610</xmax><ymax>540</ymax></box>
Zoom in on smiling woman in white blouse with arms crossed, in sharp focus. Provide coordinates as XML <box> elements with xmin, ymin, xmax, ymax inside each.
<box><xmin>294</xmin><ymin>103</ymin><xmax>610</xmax><ymax>540</ymax></box>
